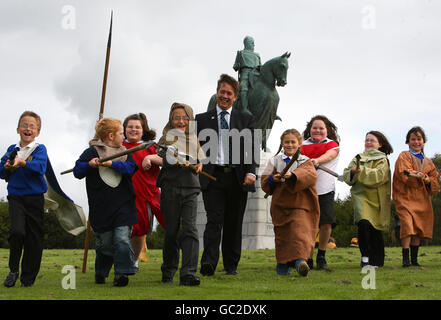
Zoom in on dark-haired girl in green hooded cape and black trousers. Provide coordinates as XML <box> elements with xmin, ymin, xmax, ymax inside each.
<box><xmin>343</xmin><ymin>131</ymin><xmax>393</xmax><ymax>267</ymax></box>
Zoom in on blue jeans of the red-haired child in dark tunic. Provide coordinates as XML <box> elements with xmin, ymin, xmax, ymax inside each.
<box><xmin>95</xmin><ymin>226</ymin><xmax>136</xmax><ymax>278</ymax></box>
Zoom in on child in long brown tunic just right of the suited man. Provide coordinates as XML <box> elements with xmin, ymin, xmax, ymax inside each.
<box><xmin>261</xmin><ymin>129</ymin><xmax>320</xmax><ymax>276</ymax></box>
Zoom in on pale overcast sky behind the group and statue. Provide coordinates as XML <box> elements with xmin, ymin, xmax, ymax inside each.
<box><xmin>0</xmin><ymin>0</ymin><xmax>441</xmax><ymax>213</ymax></box>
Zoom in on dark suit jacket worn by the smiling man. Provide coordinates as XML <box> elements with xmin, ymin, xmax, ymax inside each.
<box><xmin>195</xmin><ymin>108</ymin><xmax>259</xmax><ymax>192</ymax></box>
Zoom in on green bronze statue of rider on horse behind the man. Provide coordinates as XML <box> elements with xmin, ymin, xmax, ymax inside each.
<box><xmin>207</xmin><ymin>36</ymin><xmax>291</xmax><ymax>150</ymax></box>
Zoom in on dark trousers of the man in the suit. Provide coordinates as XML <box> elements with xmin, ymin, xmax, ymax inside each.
<box><xmin>201</xmin><ymin>168</ymin><xmax>248</xmax><ymax>271</ymax></box>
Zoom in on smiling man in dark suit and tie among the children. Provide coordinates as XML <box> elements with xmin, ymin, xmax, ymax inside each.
<box><xmin>196</xmin><ymin>74</ymin><xmax>258</xmax><ymax>276</ymax></box>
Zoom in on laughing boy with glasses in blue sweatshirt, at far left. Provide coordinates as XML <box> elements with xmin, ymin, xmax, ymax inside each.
<box><xmin>0</xmin><ymin>111</ymin><xmax>47</xmax><ymax>287</ymax></box>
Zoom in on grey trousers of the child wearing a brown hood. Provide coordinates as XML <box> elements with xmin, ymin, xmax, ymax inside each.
<box><xmin>161</xmin><ymin>187</ymin><xmax>199</xmax><ymax>278</ymax></box>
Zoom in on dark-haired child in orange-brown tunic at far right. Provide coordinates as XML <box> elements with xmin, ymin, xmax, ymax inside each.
<box><xmin>392</xmin><ymin>127</ymin><xmax>439</xmax><ymax>267</ymax></box>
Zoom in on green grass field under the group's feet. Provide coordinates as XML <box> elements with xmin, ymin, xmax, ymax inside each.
<box><xmin>0</xmin><ymin>247</ymin><xmax>441</xmax><ymax>300</ymax></box>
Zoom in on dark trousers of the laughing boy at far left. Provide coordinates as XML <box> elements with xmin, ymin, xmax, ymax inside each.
<box><xmin>8</xmin><ymin>194</ymin><xmax>44</xmax><ymax>284</ymax></box>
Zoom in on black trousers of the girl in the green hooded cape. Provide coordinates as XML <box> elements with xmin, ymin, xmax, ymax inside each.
<box><xmin>358</xmin><ymin>219</ymin><xmax>385</xmax><ymax>267</ymax></box>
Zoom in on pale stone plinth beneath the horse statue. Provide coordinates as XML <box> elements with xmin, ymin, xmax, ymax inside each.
<box><xmin>196</xmin><ymin>151</ymin><xmax>274</xmax><ymax>250</ymax></box>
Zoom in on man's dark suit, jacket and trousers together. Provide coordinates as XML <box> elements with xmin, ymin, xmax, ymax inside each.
<box><xmin>196</xmin><ymin>108</ymin><xmax>256</xmax><ymax>272</ymax></box>
